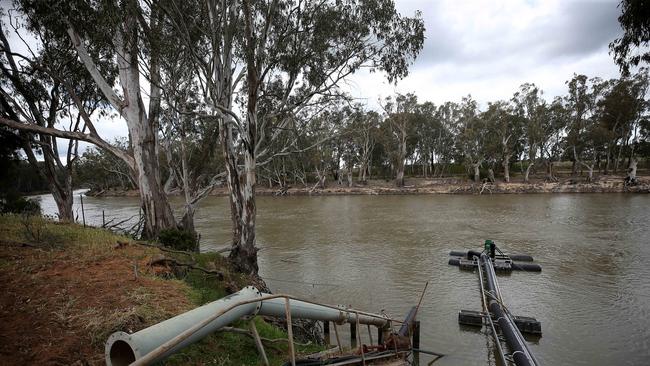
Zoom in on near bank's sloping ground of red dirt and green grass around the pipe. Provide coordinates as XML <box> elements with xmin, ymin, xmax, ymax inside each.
<box><xmin>0</xmin><ymin>215</ymin><xmax>322</xmax><ymax>365</ymax></box>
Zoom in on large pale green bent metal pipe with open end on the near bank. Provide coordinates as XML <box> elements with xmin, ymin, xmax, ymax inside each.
<box><xmin>105</xmin><ymin>287</ymin><xmax>391</xmax><ymax>366</ymax></box>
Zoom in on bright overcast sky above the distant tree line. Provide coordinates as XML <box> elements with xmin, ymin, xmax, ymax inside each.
<box><xmin>348</xmin><ymin>0</ymin><xmax>622</xmax><ymax>106</ymax></box>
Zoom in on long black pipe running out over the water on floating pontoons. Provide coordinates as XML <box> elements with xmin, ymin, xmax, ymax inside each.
<box><xmin>481</xmin><ymin>254</ymin><xmax>535</xmax><ymax>366</ymax></box>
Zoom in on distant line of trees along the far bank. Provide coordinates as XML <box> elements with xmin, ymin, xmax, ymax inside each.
<box><xmin>244</xmin><ymin>69</ymin><xmax>650</xmax><ymax>188</ymax></box>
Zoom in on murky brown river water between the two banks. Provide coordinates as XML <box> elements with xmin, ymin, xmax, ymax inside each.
<box><xmin>36</xmin><ymin>194</ymin><xmax>650</xmax><ymax>365</ymax></box>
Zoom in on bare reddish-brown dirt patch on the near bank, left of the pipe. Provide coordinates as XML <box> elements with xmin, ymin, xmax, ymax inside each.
<box><xmin>0</xmin><ymin>236</ymin><xmax>191</xmax><ymax>365</ymax></box>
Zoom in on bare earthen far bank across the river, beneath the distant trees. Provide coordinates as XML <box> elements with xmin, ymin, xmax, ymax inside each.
<box><xmin>86</xmin><ymin>175</ymin><xmax>650</xmax><ymax>197</ymax></box>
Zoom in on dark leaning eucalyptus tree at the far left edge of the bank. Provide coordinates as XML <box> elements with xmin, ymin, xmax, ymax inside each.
<box><xmin>0</xmin><ymin>13</ymin><xmax>115</xmax><ymax>221</ymax></box>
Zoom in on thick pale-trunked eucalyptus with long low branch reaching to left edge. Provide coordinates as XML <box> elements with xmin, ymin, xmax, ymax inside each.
<box><xmin>0</xmin><ymin>0</ymin><xmax>176</xmax><ymax>237</ymax></box>
